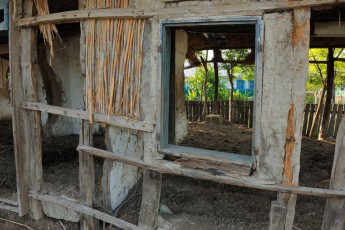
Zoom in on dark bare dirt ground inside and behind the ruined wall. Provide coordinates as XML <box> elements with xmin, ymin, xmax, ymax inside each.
<box><xmin>0</xmin><ymin>119</ymin><xmax>335</xmax><ymax>230</ymax></box>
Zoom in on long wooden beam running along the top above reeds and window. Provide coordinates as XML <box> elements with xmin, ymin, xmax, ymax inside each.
<box><xmin>18</xmin><ymin>0</ymin><xmax>345</xmax><ymax>27</ymax></box>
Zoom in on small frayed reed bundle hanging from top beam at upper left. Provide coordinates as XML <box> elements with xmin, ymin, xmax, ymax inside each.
<box><xmin>34</xmin><ymin>0</ymin><xmax>61</xmax><ymax>57</ymax></box>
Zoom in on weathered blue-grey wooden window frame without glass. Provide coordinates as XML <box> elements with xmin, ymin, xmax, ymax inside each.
<box><xmin>159</xmin><ymin>17</ymin><xmax>263</xmax><ymax>165</ymax></box>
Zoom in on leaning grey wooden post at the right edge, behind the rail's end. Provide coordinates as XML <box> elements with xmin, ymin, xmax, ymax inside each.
<box><xmin>321</xmin><ymin>118</ymin><xmax>345</xmax><ymax>230</ymax></box>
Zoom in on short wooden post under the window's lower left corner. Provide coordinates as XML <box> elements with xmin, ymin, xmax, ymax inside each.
<box><xmin>138</xmin><ymin>170</ymin><xmax>162</xmax><ymax>230</ymax></box>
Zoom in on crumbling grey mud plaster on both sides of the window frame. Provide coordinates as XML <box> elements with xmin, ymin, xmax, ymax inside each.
<box><xmin>102</xmin><ymin>0</ymin><xmax>307</xmax><ymax>212</ymax></box>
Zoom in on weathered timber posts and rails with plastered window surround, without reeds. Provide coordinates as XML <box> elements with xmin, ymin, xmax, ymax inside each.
<box><xmin>0</xmin><ymin>0</ymin><xmax>345</xmax><ymax>230</ymax></box>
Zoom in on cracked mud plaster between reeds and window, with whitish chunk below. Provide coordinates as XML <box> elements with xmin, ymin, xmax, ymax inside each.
<box><xmin>102</xmin><ymin>17</ymin><xmax>162</xmax><ymax>209</ymax></box>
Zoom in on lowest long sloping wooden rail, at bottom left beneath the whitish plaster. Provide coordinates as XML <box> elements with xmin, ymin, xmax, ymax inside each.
<box><xmin>29</xmin><ymin>192</ymin><xmax>144</xmax><ymax>230</ymax></box>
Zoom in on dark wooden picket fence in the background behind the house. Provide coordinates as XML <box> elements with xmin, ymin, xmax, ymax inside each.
<box><xmin>186</xmin><ymin>100</ymin><xmax>344</xmax><ymax>138</ymax></box>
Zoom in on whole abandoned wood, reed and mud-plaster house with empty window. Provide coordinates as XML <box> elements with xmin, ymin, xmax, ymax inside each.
<box><xmin>0</xmin><ymin>0</ymin><xmax>345</xmax><ymax>230</ymax></box>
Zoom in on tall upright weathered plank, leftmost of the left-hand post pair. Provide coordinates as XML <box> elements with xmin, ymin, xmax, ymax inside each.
<box><xmin>9</xmin><ymin>1</ymin><xmax>29</xmax><ymax>216</ymax></box>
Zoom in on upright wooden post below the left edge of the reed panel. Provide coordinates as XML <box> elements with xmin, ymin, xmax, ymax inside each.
<box><xmin>79</xmin><ymin>120</ymin><xmax>97</xmax><ymax>230</ymax></box>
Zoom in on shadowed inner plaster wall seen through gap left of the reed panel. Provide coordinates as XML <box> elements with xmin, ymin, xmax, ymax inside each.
<box><xmin>38</xmin><ymin>36</ymin><xmax>85</xmax><ymax>136</ymax></box>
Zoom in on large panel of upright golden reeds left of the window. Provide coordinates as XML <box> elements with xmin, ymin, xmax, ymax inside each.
<box><xmin>85</xmin><ymin>0</ymin><xmax>145</xmax><ymax>121</ymax></box>
